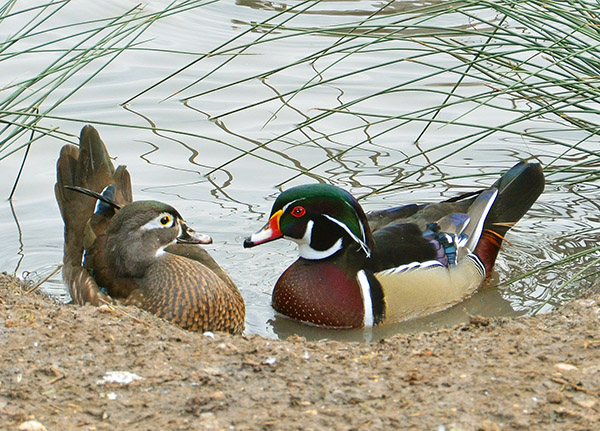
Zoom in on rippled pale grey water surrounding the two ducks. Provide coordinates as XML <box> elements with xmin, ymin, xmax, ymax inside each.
<box><xmin>0</xmin><ymin>0</ymin><xmax>600</xmax><ymax>340</ymax></box>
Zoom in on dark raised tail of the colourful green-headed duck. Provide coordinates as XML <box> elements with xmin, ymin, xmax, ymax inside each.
<box><xmin>475</xmin><ymin>161</ymin><xmax>545</xmax><ymax>275</ymax></box>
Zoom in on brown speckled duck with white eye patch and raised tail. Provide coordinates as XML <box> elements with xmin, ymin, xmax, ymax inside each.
<box><xmin>55</xmin><ymin>126</ymin><xmax>245</xmax><ymax>334</ymax></box>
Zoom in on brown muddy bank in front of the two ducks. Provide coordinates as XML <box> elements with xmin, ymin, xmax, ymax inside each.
<box><xmin>0</xmin><ymin>276</ymin><xmax>600</xmax><ymax>431</ymax></box>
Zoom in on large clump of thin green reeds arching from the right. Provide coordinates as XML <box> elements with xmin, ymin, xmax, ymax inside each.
<box><xmin>130</xmin><ymin>0</ymin><xmax>600</xmax><ymax>302</ymax></box>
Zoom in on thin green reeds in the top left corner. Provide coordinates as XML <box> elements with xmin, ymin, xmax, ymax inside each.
<box><xmin>0</xmin><ymin>0</ymin><xmax>220</xmax><ymax>189</ymax></box>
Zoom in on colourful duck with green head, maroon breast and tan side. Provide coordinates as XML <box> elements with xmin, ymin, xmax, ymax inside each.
<box><xmin>244</xmin><ymin>162</ymin><xmax>544</xmax><ymax>328</ymax></box>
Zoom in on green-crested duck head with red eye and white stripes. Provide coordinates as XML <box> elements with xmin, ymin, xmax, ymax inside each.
<box><xmin>244</xmin><ymin>184</ymin><xmax>373</xmax><ymax>260</ymax></box>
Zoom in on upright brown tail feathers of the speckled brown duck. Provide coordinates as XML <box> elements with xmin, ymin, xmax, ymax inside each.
<box><xmin>54</xmin><ymin>125</ymin><xmax>131</xmax><ymax>305</ymax></box>
